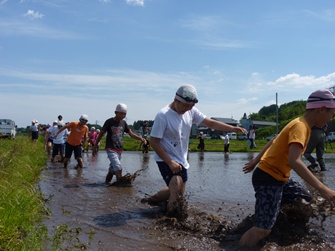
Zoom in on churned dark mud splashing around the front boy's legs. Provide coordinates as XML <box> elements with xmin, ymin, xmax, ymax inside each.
<box><xmin>146</xmin><ymin>199</ymin><xmax>335</xmax><ymax>250</ymax></box>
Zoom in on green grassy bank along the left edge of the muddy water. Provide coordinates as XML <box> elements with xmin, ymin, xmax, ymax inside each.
<box><xmin>0</xmin><ymin>137</ymin><xmax>47</xmax><ymax>251</ymax></box>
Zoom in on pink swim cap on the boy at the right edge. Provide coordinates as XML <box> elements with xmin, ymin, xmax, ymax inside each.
<box><xmin>306</xmin><ymin>90</ymin><xmax>335</xmax><ymax>109</ymax></box>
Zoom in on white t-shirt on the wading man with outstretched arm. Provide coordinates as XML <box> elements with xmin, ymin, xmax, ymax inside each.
<box><xmin>150</xmin><ymin>105</ymin><xmax>206</xmax><ymax>169</ymax></box>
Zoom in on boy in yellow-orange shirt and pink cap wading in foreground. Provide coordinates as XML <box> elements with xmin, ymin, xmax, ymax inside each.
<box><xmin>240</xmin><ymin>90</ymin><xmax>335</xmax><ymax>247</ymax></box>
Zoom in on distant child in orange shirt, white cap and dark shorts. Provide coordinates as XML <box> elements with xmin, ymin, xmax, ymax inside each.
<box><xmin>54</xmin><ymin>114</ymin><xmax>88</xmax><ymax>168</ymax></box>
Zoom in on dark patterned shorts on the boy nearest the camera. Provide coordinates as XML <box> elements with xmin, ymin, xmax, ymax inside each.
<box><xmin>254</xmin><ymin>179</ymin><xmax>313</xmax><ymax>229</ymax></box>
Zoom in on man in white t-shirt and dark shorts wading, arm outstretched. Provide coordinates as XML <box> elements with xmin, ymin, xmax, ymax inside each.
<box><xmin>141</xmin><ymin>85</ymin><xmax>247</xmax><ymax>216</ymax></box>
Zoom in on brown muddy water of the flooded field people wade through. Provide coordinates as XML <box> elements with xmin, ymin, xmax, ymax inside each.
<box><xmin>39</xmin><ymin>151</ymin><xmax>335</xmax><ymax>251</ymax></box>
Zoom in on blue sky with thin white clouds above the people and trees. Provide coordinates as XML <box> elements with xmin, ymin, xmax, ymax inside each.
<box><xmin>0</xmin><ymin>0</ymin><xmax>335</xmax><ymax>127</ymax></box>
